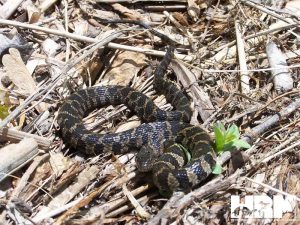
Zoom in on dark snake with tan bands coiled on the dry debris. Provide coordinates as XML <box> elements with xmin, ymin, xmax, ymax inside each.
<box><xmin>57</xmin><ymin>23</ymin><xmax>216</xmax><ymax>195</ymax></box>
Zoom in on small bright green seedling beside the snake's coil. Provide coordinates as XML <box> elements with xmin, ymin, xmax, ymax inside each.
<box><xmin>213</xmin><ymin>123</ymin><xmax>251</xmax><ymax>174</ymax></box>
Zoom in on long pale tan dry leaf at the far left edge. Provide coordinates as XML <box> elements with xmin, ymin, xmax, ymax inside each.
<box><xmin>2</xmin><ymin>48</ymin><xmax>37</xmax><ymax>95</ymax></box>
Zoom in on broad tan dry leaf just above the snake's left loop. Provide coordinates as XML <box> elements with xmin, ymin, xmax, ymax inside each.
<box><xmin>105</xmin><ymin>51</ymin><xmax>146</xmax><ymax>86</ymax></box>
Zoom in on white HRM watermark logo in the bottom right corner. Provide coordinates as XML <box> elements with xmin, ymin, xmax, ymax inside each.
<box><xmin>231</xmin><ymin>195</ymin><xmax>296</xmax><ymax>219</ymax></box>
